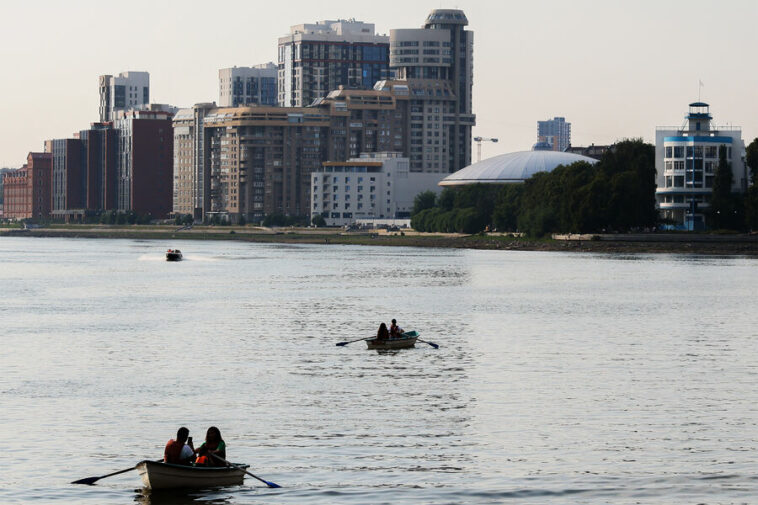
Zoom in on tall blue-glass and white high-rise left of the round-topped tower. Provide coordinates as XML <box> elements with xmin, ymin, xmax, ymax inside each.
<box><xmin>278</xmin><ymin>19</ymin><xmax>389</xmax><ymax>107</ymax></box>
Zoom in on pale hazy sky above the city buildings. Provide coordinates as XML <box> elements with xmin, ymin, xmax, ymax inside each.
<box><xmin>0</xmin><ymin>0</ymin><xmax>758</xmax><ymax>167</ymax></box>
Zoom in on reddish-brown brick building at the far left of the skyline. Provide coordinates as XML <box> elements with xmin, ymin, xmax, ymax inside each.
<box><xmin>2</xmin><ymin>153</ymin><xmax>52</xmax><ymax>219</ymax></box>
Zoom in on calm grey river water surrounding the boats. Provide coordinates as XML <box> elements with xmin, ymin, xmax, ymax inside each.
<box><xmin>0</xmin><ymin>238</ymin><xmax>758</xmax><ymax>505</ymax></box>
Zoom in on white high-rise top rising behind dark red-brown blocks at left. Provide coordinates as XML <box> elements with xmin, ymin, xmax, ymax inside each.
<box><xmin>99</xmin><ymin>71</ymin><xmax>150</xmax><ymax>122</ymax></box>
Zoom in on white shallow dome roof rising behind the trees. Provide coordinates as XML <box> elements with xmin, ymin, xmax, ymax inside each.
<box><xmin>439</xmin><ymin>151</ymin><xmax>597</xmax><ymax>186</ymax></box>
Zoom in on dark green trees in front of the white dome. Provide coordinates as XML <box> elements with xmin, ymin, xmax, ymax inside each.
<box><xmin>411</xmin><ymin>139</ymin><xmax>657</xmax><ymax>237</ymax></box>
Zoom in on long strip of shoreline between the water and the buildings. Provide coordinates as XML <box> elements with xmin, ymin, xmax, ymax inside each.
<box><xmin>0</xmin><ymin>225</ymin><xmax>758</xmax><ymax>256</ymax></box>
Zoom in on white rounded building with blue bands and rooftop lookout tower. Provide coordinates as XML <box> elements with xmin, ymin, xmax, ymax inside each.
<box><xmin>655</xmin><ymin>102</ymin><xmax>748</xmax><ymax>230</ymax></box>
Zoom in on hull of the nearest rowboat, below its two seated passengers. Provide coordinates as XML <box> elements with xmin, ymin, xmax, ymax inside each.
<box><xmin>137</xmin><ymin>460</ymin><xmax>249</xmax><ymax>489</ymax></box>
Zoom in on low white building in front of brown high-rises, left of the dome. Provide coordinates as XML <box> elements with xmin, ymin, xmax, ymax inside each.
<box><xmin>311</xmin><ymin>153</ymin><xmax>444</xmax><ymax>226</ymax></box>
